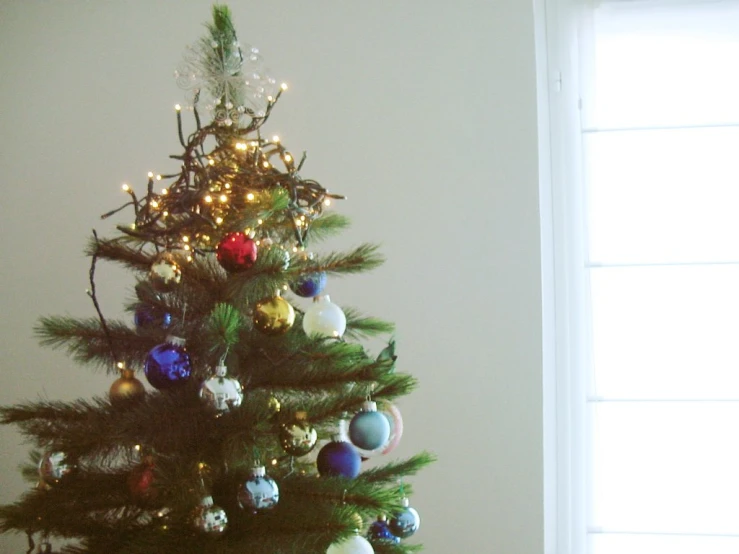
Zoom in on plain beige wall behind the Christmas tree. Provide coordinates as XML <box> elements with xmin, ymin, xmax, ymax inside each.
<box><xmin>0</xmin><ymin>0</ymin><xmax>544</xmax><ymax>554</ymax></box>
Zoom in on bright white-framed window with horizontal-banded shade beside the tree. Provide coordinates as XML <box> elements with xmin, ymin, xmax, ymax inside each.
<box><xmin>546</xmin><ymin>0</ymin><xmax>739</xmax><ymax>554</ymax></box>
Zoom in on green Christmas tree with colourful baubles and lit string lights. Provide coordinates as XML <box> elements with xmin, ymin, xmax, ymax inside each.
<box><xmin>0</xmin><ymin>6</ymin><xmax>432</xmax><ymax>554</ymax></box>
